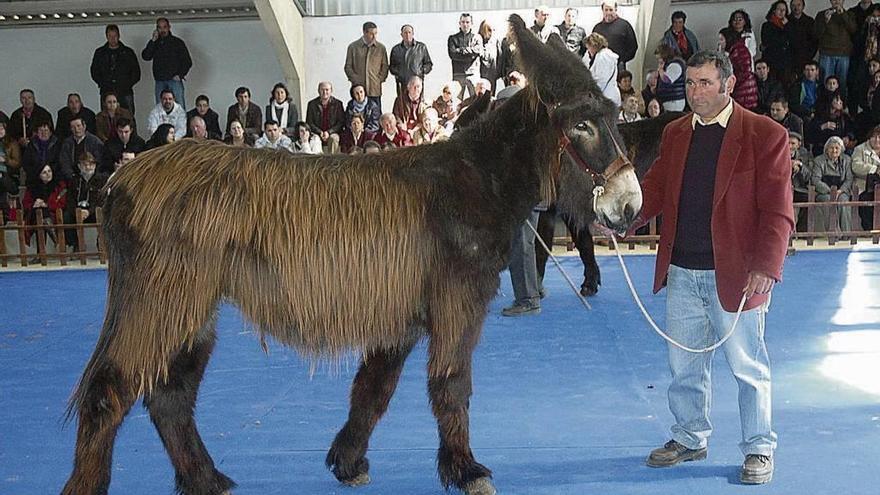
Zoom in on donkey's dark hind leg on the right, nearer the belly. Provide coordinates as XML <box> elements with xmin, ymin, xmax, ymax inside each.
<box><xmin>144</xmin><ymin>317</ymin><xmax>235</xmax><ymax>495</ymax></box>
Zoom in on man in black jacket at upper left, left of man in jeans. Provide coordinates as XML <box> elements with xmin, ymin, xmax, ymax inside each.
<box><xmin>91</xmin><ymin>24</ymin><xmax>141</xmax><ymax>115</ymax></box>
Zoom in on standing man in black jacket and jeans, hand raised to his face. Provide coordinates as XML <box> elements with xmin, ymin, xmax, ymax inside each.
<box><xmin>141</xmin><ymin>17</ymin><xmax>192</xmax><ymax>108</ymax></box>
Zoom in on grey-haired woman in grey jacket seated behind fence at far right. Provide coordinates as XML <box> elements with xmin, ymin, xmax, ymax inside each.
<box><xmin>810</xmin><ymin>136</ymin><xmax>853</xmax><ymax>232</ymax></box>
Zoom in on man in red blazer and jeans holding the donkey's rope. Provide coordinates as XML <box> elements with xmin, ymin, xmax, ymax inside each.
<box><xmin>636</xmin><ymin>50</ymin><xmax>794</xmax><ymax>484</ymax></box>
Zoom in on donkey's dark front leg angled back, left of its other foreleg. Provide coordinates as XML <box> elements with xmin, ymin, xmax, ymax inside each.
<box><xmin>326</xmin><ymin>335</ymin><xmax>418</xmax><ymax>486</ymax></box>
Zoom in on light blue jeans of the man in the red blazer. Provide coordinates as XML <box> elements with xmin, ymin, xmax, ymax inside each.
<box><xmin>666</xmin><ymin>265</ymin><xmax>776</xmax><ymax>455</ymax></box>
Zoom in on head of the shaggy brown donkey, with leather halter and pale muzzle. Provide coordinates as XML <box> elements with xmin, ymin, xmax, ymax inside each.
<box><xmin>510</xmin><ymin>14</ymin><xmax>642</xmax><ymax>230</ymax></box>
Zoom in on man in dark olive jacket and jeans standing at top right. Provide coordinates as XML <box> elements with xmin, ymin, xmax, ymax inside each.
<box><xmin>814</xmin><ymin>0</ymin><xmax>858</xmax><ymax>97</ymax></box>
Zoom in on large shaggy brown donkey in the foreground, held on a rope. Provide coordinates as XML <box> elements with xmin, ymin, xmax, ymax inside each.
<box><xmin>62</xmin><ymin>16</ymin><xmax>641</xmax><ymax>495</ymax></box>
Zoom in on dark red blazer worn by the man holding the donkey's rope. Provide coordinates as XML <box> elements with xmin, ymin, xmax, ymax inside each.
<box><xmin>637</xmin><ymin>102</ymin><xmax>794</xmax><ymax>312</ymax></box>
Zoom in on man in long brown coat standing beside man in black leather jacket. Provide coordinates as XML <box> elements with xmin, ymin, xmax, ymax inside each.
<box><xmin>344</xmin><ymin>22</ymin><xmax>388</xmax><ymax>111</ymax></box>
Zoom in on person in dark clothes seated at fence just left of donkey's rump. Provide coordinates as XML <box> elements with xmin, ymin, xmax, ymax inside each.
<box><xmin>64</xmin><ymin>151</ymin><xmax>108</xmax><ymax>250</ymax></box>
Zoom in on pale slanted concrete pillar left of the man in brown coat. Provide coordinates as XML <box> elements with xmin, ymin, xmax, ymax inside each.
<box><xmin>254</xmin><ymin>0</ymin><xmax>308</xmax><ymax>115</ymax></box>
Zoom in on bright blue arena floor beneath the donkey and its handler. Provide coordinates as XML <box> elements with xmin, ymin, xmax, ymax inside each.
<box><xmin>0</xmin><ymin>250</ymin><xmax>880</xmax><ymax>495</ymax></box>
